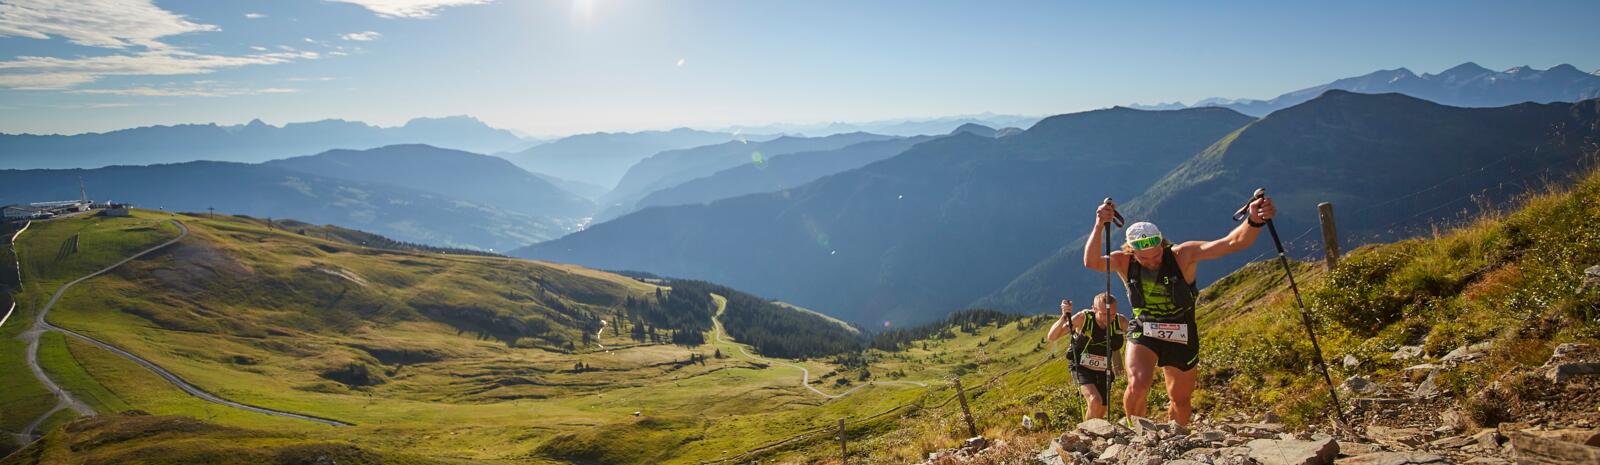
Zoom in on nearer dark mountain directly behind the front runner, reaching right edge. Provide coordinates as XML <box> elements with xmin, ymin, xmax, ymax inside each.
<box><xmin>976</xmin><ymin>91</ymin><xmax>1600</xmax><ymax>308</ymax></box>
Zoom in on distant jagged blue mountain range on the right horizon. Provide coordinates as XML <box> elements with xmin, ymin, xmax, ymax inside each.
<box><xmin>1131</xmin><ymin>62</ymin><xmax>1600</xmax><ymax>117</ymax></box>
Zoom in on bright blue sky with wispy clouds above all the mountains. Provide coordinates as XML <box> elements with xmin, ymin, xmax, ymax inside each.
<box><xmin>0</xmin><ymin>0</ymin><xmax>1600</xmax><ymax>134</ymax></box>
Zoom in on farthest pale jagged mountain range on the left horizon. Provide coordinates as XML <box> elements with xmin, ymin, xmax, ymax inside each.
<box><xmin>0</xmin><ymin>117</ymin><xmax>523</xmax><ymax>169</ymax></box>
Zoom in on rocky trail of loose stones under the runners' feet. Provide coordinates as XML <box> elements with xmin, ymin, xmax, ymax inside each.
<box><xmin>922</xmin><ymin>344</ymin><xmax>1600</xmax><ymax>465</ymax></box>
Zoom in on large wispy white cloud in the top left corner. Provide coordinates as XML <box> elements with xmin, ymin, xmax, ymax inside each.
<box><xmin>0</xmin><ymin>0</ymin><xmax>320</xmax><ymax>89</ymax></box>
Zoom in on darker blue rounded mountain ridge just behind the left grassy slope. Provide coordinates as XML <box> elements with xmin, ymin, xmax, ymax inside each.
<box><xmin>0</xmin><ymin>145</ymin><xmax>594</xmax><ymax>251</ymax></box>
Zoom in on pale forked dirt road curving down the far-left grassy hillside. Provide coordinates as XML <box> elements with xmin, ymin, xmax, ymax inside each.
<box><xmin>18</xmin><ymin>221</ymin><xmax>349</xmax><ymax>444</ymax></box>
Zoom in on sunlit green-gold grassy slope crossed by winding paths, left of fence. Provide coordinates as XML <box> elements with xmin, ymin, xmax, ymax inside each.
<box><xmin>0</xmin><ymin>209</ymin><xmax>914</xmax><ymax>463</ymax></box>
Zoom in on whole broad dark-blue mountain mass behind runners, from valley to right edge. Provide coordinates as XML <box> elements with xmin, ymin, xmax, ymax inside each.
<box><xmin>514</xmin><ymin>91</ymin><xmax>1600</xmax><ymax>323</ymax></box>
